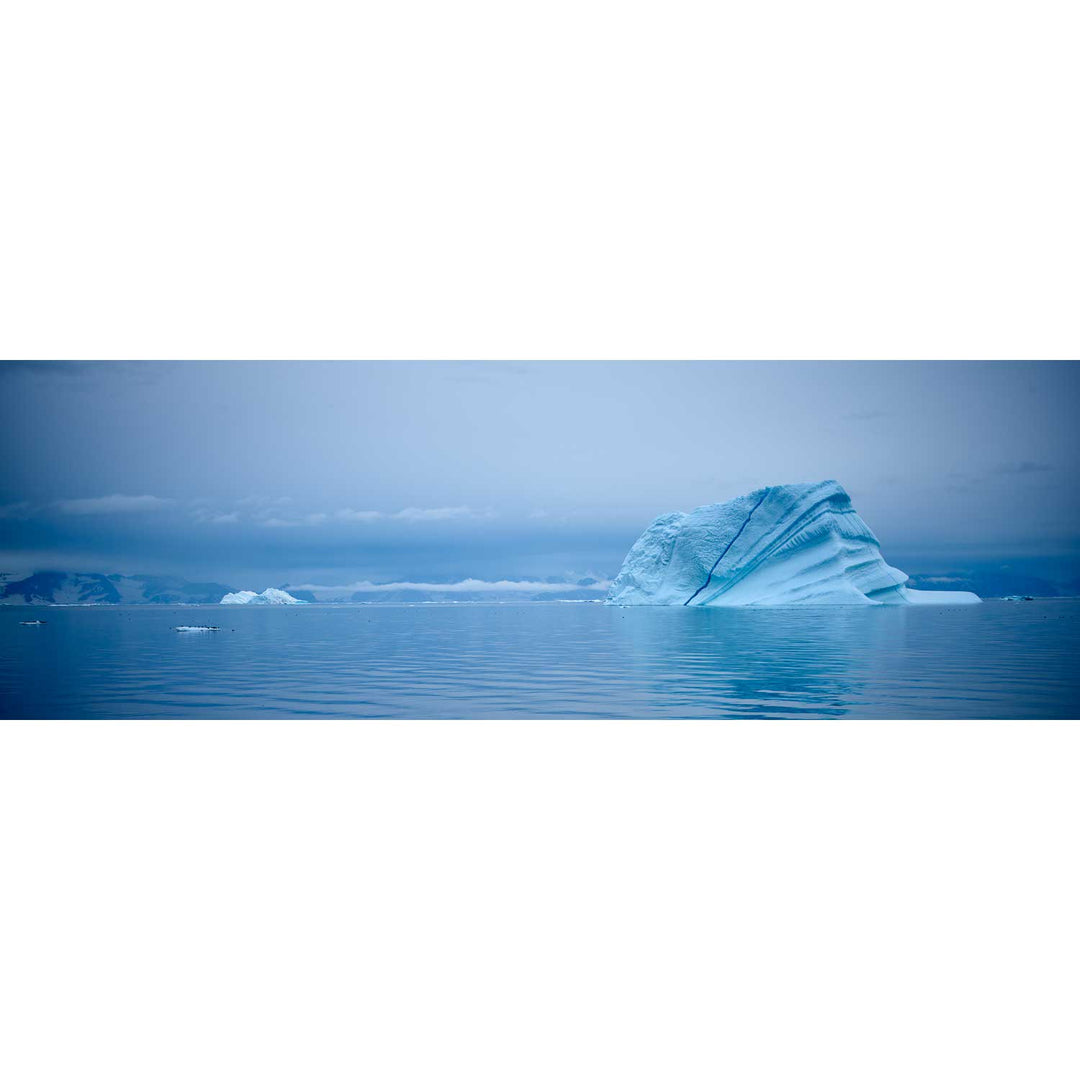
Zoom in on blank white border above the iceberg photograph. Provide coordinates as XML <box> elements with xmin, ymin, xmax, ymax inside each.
<box><xmin>0</xmin><ymin>0</ymin><xmax>1080</xmax><ymax>359</ymax></box>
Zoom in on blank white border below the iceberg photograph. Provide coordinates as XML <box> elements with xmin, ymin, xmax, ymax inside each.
<box><xmin>0</xmin><ymin>723</ymin><xmax>1080</xmax><ymax>1080</ymax></box>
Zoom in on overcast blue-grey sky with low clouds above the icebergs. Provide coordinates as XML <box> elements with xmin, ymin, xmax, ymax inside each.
<box><xmin>0</xmin><ymin>362</ymin><xmax>1080</xmax><ymax>589</ymax></box>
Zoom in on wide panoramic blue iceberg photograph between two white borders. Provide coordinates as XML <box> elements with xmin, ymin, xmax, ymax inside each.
<box><xmin>0</xmin><ymin>361</ymin><xmax>1080</xmax><ymax>719</ymax></box>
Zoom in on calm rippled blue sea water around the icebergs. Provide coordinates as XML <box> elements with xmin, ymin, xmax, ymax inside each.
<box><xmin>0</xmin><ymin>600</ymin><xmax>1080</xmax><ymax>719</ymax></box>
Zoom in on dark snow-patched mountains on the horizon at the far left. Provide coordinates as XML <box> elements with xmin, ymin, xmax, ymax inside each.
<box><xmin>0</xmin><ymin>570</ymin><xmax>235</xmax><ymax>604</ymax></box>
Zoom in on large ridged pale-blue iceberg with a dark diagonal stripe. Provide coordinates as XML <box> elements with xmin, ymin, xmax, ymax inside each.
<box><xmin>607</xmin><ymin>481</ymin><xmax>978</xmax><ymax>607</ymax></box>
